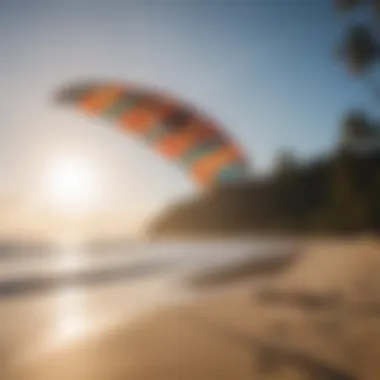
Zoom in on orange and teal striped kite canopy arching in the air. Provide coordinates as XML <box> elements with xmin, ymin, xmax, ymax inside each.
<box><xmin>55</xmin><ymin>81</ymin><xmax>248</xmax><ymax>187</ymax></box>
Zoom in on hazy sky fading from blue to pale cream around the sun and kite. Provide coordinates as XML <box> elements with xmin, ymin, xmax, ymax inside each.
<box><xmin>0</xmin><ymin>0</ymin><xmax>369</xmax><ymax>236</ymax></box>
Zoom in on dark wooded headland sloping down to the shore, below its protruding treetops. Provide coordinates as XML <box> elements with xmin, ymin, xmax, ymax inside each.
<box><xmin>149</xmin><ymin>148</ymin><xmax>380</xmax><ymax>235</ymax></box>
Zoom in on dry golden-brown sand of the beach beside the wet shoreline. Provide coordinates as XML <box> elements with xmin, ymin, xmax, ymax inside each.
<box><xmin>6</xmin><ymin>239</ymin><xmax>380</xmax><ymax>380</ymax></box>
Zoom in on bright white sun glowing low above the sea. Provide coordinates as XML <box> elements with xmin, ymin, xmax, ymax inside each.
<box><xmin>43</xmin><ymin>157</ymin><xmax>99</xmax><ymax>214</ymax></box>
